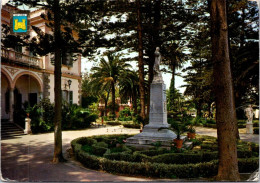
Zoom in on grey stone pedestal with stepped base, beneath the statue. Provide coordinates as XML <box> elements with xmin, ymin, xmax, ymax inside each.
<box><xmin>126</xmin><ymin>77</ymin><xmax>177</xmax><ymax>146</ymax></box>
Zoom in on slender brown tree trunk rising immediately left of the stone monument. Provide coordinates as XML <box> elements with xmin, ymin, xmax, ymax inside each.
<box><xmin>136</xmin><ymin>0</ymin><xmax>145</xmax><ymax>119</ymax></box>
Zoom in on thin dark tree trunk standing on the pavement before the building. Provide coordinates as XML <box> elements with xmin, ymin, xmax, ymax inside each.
<box><xmin>53</xmin><ymin>0</ymin><xmax>64</xmax><ymax>163</ymax></box>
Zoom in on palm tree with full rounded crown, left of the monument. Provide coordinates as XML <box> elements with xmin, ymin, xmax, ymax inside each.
<box><xmin>91</xmin><ymin>53</ymin><xmax>131</xmax><ymax>118</ymax></box>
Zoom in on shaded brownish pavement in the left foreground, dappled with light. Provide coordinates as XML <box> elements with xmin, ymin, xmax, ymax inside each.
<box><xmin>1</xmin><ymin>139</ymin><xmax>152</xmax><ymax>182</ymax></box>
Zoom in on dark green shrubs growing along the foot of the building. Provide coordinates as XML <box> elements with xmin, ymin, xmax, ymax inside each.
<box><xmin>20</xmin><ymin>99</ymin><xmax>98</xmax><ymax>134</ymax></box>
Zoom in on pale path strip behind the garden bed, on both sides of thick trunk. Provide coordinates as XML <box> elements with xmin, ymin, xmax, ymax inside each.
<box><xmin>195</xmin><ymin>127</ymin><xmax>259</xmax><ymax>144</ymax></box>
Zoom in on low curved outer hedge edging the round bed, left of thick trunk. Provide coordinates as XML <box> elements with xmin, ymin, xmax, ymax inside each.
<box><xmin>71</xmin><ymin>139</ymin><xmax>217</xmax><ymax>178</ymax></box>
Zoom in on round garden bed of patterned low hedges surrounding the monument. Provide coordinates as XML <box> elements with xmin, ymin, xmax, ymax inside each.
<box><xmin>71</xmin><ymin>135</ymin><xmax>259</xmax><ymax>178</ymax></box>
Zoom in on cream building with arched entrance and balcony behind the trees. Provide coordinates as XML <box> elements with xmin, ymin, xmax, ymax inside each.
<box><xmin>1</xmin><ymin>5</ymin><xmax>81</xmax><ymax>121</ymax></box>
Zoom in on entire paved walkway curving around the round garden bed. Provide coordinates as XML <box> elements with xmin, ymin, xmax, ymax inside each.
<box><xmin>1</xmin><ymin>126</ymin><xmax>259</xmax><ymax>182</ymax></box>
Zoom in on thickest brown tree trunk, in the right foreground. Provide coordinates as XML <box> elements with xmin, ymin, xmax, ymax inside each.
<box><xmin>208</xmin><ymin>0</ymin><xmax>240</xmax><ymax>181</ymax></box>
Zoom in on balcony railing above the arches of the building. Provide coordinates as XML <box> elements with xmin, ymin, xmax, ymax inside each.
<box><xmin>1</xmin><ymin>48</ymin><xmax>43</xmax><ymax>69</ymax></box>
